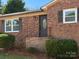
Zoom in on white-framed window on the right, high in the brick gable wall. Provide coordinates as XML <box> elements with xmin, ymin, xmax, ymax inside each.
<box><xmin>63</xmin><ymin>8</ymin><xmax>77</xmax><ymax>23</ymax></box>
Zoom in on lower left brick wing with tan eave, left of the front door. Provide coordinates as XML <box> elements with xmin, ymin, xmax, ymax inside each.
<box><xmin>0</xmin><ymin>11</ymin><xmax>46</xmax><ymax>47</ymax></box>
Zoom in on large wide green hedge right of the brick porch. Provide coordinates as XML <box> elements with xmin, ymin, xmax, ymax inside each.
<box><xmin>46</xmin><ymin>39</ymin><xmax>78</xmax><ymax>59</ymax></box>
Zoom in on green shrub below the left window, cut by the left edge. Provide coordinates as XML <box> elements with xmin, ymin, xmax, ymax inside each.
<box><xmin>0</xmin><ymin>33</ymin><xmax>15</xmax><ymax>48</ymax></box>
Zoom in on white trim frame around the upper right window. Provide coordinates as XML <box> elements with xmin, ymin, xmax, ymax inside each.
<box><xmin>63</xmin><ymin>8</ymin><xmax>77</xmax><ymax>24</ymax></box>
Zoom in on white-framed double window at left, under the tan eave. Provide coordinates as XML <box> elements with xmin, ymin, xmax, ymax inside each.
<box><xmin>5</xmin><ymin>19</ymin><xmax>19</xmax><ymax>32</ymax></box>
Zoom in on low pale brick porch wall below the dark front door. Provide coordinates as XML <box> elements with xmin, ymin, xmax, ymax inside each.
<box><xmin>25</xmin><ymin>37</ymin><xmax>49</xmax><ymax>52</ymax></box>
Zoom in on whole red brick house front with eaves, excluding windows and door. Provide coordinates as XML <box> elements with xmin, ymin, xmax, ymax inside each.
<box><xmin>0</xmin><ymin>0</ymin><xmax>79</xmax><ymax>48</ymax></box>
